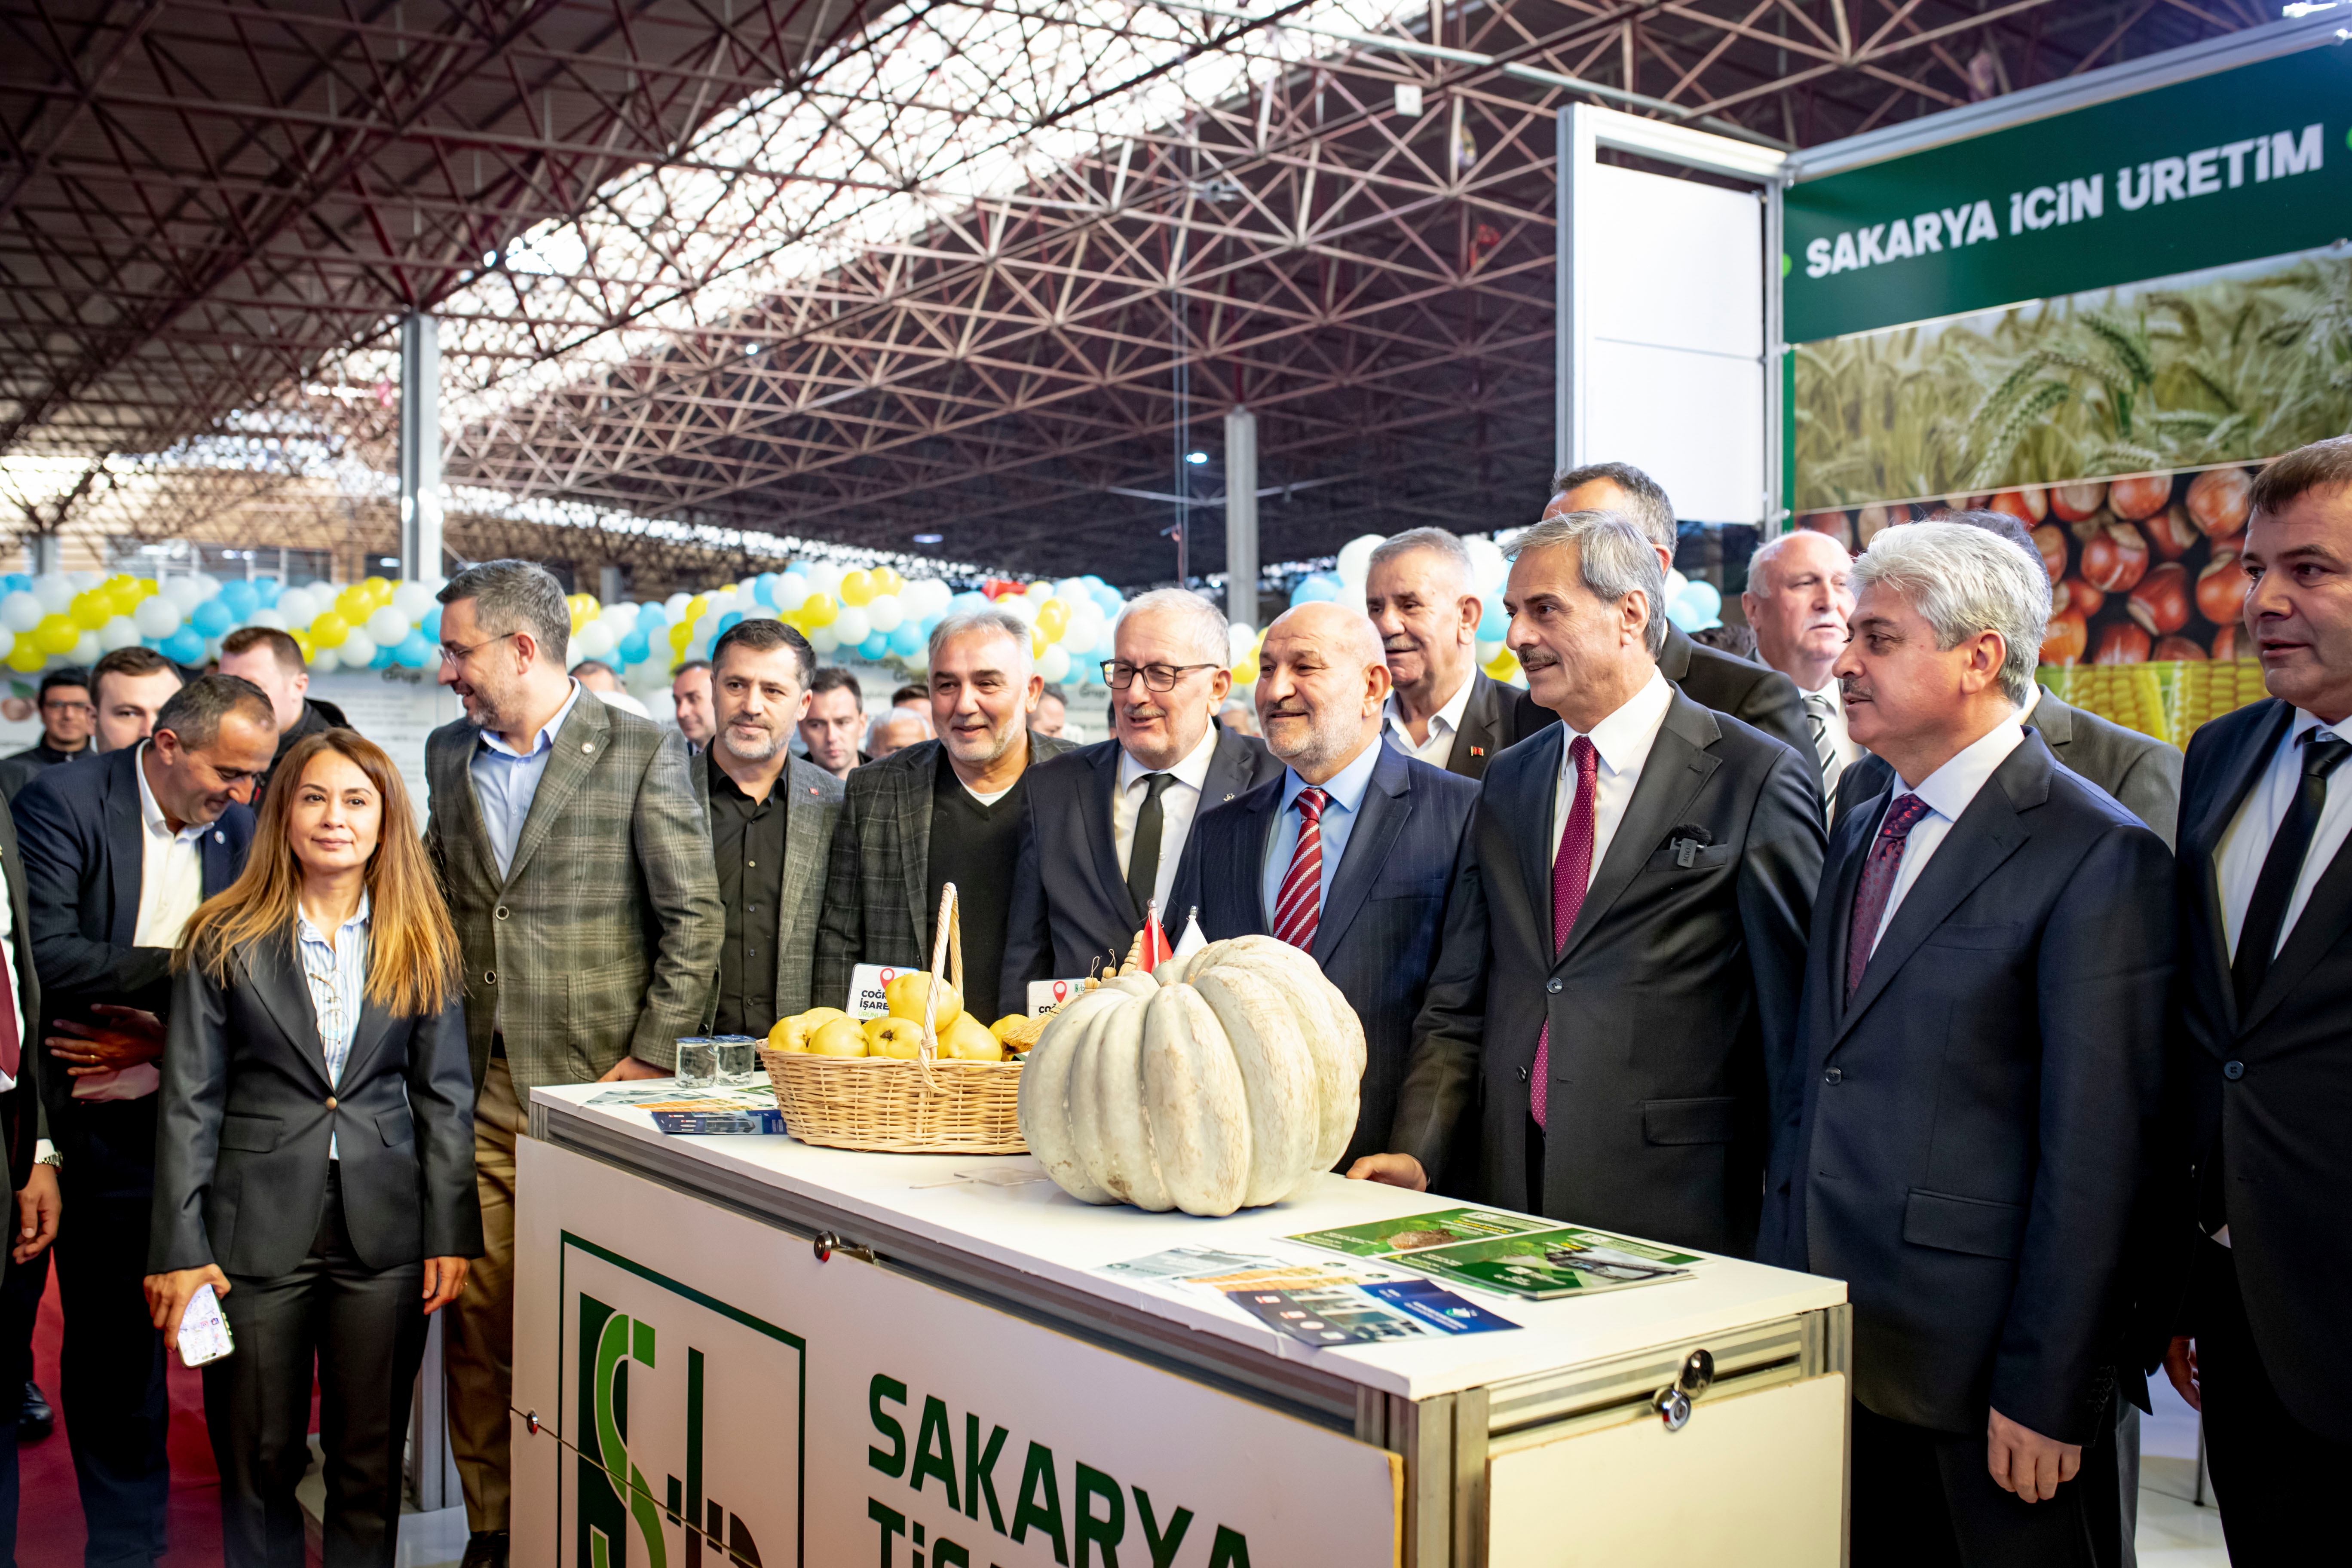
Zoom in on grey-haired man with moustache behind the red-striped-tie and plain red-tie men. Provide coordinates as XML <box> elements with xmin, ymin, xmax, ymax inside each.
<box><xmin>1364</xmin><ymin>529</ymin><xmax>1519</xmax><ymax>778</ymax></box>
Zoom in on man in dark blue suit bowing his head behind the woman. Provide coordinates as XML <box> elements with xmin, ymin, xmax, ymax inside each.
<box><xmin>0</xmin><ymin>675</ymin><xmax>278</xmax><ymax>1563</ymax></box>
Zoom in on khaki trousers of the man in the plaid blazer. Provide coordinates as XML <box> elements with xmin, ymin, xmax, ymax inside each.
<box><xmin>442</xmin><ymin>1056</ymin><xmax>527</xmax><ymax>1530</ymax></box>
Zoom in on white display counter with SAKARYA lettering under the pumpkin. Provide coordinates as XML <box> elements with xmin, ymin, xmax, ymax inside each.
<box><xmin>513</xmin><ymin>1086</ymin><xmax>1849</xmax><ymax>1568</ymax></box>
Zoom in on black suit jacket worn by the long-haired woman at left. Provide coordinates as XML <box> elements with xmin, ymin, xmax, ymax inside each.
<box><xmin>148</xmin><ymin>933</ymin><xmax>482</xmax><ymax>1279</ymax></box>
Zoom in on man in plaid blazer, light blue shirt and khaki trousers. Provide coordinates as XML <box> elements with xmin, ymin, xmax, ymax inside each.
<box><xmin>426</xmin><ymin>560</ymin><xmax>727</xmax><ymax>1568</ymax></box>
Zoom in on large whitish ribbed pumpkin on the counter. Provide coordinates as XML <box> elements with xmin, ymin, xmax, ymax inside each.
<box><xmin>1021</xmin><ymin>936</ymin><xmax>1364</xmax><ymax>1216</ymax></box>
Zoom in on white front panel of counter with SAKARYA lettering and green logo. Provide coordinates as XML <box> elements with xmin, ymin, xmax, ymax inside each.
<box><xmin>513</xmin><ymin>1140</ymin><xmax>1402</xmax><ymax>1568</ymax></box>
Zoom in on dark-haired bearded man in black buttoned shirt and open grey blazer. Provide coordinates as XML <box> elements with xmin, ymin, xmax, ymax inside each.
<box><xmin>694</xmin><ymin>621</ymin><xmax>842</xmax><ymax>1034</ymax></box>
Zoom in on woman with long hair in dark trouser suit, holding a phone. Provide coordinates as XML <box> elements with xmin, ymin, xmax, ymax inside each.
<box><xmin>146</xmin><ymin>729</ymin><xmax>482</xmax><ymax>1568</ymax></box>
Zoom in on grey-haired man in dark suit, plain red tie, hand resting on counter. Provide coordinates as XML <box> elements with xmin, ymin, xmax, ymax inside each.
<box><xmin>1350</xmin><ymin>512</ymin><xmax>1823</xmax><ymax>1256</ymax></box>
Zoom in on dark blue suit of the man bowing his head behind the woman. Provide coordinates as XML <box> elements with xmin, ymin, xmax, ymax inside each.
<box><xmin>12</xmin><ymin>747</ymin><xmax>254</xmax><ymax>1568</ymax></box>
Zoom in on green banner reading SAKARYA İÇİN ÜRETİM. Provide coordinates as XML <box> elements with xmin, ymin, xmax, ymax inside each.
<box><xmin>1783</xmin><ymin>47</ymin><xmax>2352</xmax><ymax>343</ymax></box>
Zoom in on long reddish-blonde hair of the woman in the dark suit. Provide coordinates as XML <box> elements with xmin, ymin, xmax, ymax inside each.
<box><xmin>172</xmin><ymin>729</ymin><xmax>459</xmax><ymax>1018</ymax></box>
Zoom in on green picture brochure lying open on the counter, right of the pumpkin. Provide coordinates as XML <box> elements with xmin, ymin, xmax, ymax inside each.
<box><xmin>1286</xmin><ymin>1208</ymin><xmax>1703</xmax><ymax>1300</ymax></box>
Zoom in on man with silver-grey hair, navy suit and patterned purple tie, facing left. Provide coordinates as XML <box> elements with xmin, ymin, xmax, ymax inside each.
<box><xmin>1759</xmin><ymin>522</ymin><xmax>2173</xmax><ymax>1566</ymax></box>
